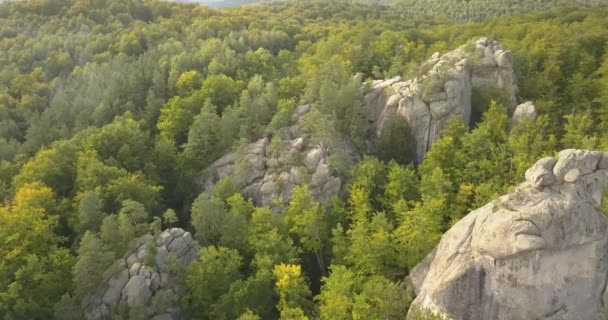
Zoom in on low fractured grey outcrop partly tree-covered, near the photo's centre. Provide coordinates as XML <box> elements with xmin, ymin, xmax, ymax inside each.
<box><xmin>198</xmin><ymin>105</ymin><xmax>357</xmax><ymax>208</ymax></box>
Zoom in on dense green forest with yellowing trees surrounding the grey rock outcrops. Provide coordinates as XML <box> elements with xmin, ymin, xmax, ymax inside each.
<box><xmin>0</xmin><ymin>0</ymin><xmax>608</xmax><ymax>320</ymax></box>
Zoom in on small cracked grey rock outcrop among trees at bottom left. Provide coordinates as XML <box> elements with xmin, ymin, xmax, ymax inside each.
<box><xmin>82</xmin><ymin>228</ymin><xmax>197</xmax><ymax>320</ymax></box>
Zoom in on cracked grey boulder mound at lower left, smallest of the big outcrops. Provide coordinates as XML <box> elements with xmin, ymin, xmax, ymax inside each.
<box><xmin>81</xmin><ymin>228</ymin><xmax>198</xmax><ymax>320</ymax></box>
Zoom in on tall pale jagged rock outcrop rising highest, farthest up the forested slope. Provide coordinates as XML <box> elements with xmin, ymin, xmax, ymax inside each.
<box><xmin>365</xmin><ymin>38</ymin><xmax>517</xmax><ymax>162</ymax></box>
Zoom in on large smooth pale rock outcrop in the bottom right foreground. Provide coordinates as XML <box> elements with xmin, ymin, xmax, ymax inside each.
<box><xmin>411</xmin><ymin>149</ymin><xmax>608</xmax><ymax>320</ymax></box>
